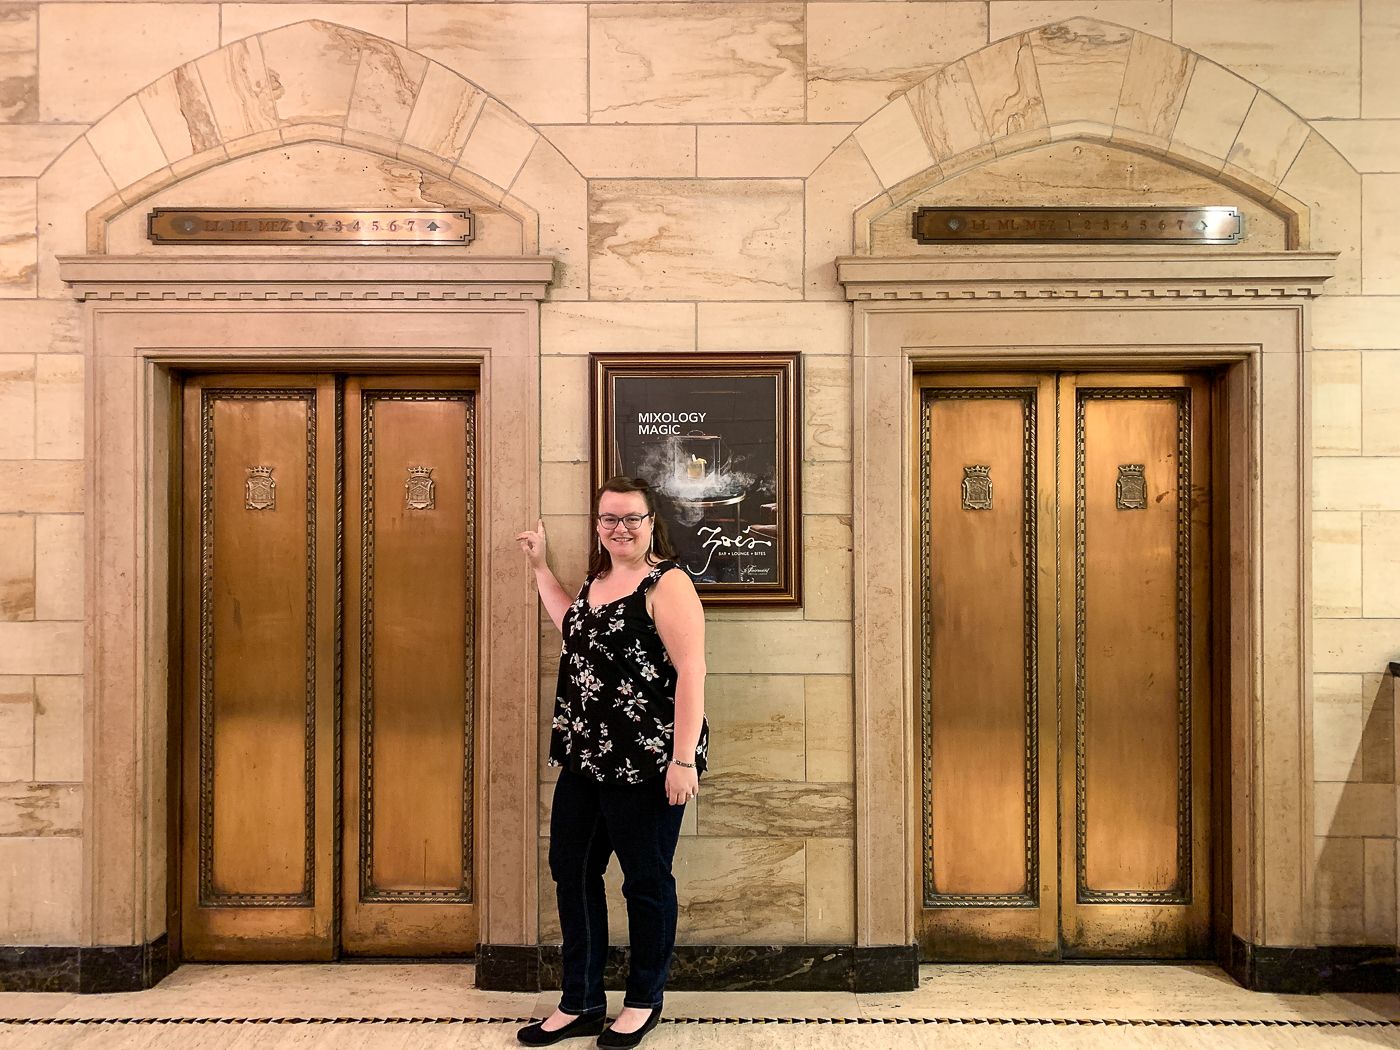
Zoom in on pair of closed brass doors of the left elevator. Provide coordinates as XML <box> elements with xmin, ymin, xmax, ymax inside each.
<box><xmin>179</xmin><ymin>375</ymin><xmax>477</xmax><ymax>960</ymax></box>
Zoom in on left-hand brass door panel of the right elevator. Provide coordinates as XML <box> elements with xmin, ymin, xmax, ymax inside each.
<box><xmin>920</xmin><ymin>375</ymin><xmax>1056</xmax><ymax>959</ymax></box>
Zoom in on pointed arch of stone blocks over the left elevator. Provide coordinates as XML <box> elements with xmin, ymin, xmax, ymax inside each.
<box><xmin>39</xmin><ymin>20</ymin><xmax>587</xmax><ymax>298</ymax></box>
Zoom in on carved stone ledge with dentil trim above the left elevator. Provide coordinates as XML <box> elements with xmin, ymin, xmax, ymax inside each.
<box><xmin>59</xmin><ymin>255</ymin><xmax>554</xmax><ymax>301</ymax></box>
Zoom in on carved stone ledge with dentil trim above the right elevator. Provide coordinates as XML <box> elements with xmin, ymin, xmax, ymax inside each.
<box><xmin>836</xmin><ymin>252</ymin><xmax>1337</xmax><ymax>302</ymax></box>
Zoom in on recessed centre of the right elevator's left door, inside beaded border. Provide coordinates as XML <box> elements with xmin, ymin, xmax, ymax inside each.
<box><xmin>928</xmin><ymin>391</ymin><xmax>1035</xmax><ymax>899</ymax></box>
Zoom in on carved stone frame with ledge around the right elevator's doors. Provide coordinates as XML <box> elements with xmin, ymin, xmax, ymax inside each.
<box><xmin>836</xmin><ymin>245</ymin><xmax>1337</xmax><ymax>981</ymax></box>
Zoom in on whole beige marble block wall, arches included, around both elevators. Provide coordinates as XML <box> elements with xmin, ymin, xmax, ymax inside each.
<box><xmin>0</xmin><ymin>0</ymin><xmax>1400</xmax><ymax>968</ymax></box>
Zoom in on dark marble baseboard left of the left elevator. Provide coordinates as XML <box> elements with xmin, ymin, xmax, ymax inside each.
<box><xmin>0</xmin><ymin>934</ymin><xmax>175</xmax><ymax>994</ymax></box>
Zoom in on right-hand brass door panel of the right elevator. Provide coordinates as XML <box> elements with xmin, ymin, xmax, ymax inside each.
<box><xmin>1060</xmin><ymin>375</ymin><xmax>1211</xmax><ymax>958</ymax></box>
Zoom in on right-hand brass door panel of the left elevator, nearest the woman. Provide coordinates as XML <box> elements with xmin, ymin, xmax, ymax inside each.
<box><xmin>342</xmin><ymin>378</ymin><xmax>476</xmax><ymax>955</ymax></box>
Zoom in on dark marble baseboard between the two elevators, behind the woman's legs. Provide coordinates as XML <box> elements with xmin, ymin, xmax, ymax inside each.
<box><xmin>476</xmin><ymin>944</ymin><xmax>918</xmax><ymax>991</ymax></box>
